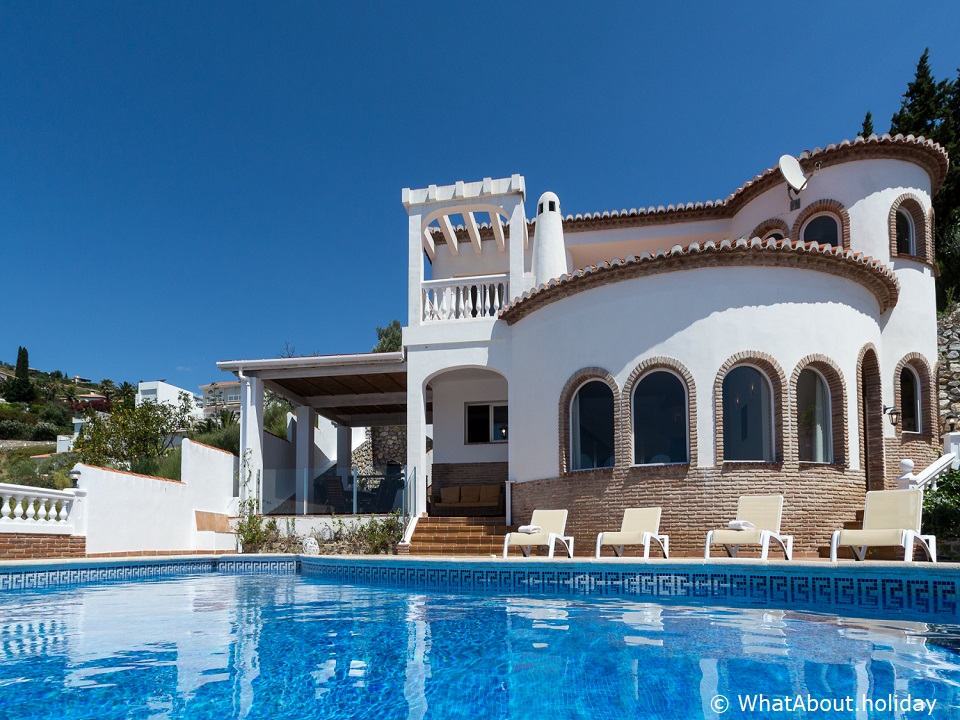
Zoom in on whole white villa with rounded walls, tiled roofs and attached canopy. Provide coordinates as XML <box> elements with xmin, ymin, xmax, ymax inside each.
<box><xmin>218</xmin><ymin>135</ymin><xmax>948</xmax><ymax>555</ymax></box>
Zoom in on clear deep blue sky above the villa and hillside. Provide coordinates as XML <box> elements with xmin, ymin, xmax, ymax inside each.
<box><xmin>0</xmin><ymin>0</ymin><xmax>960</xmax><ymax>389</ymax></box>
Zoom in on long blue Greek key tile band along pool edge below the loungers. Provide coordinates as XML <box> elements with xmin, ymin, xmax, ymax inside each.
<box><xmin>301</xmin><ymin>558</ymin><xmax>960</xmax><ymax>622</ymax></box>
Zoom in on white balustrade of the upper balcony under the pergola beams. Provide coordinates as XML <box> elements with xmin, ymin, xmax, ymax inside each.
<box><xmin>420</xmin><ymin>274</ymin><xmax>509</xmax><ymax>322</ymax></box>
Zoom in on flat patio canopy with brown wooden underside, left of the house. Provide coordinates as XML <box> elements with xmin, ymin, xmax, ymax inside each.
<box><xmin>217</xmin><ymin>352</ymin><xmax>433</xmax><ymax>427</ymax></box>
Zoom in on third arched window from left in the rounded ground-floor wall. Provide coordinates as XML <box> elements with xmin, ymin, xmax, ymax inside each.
<box><xmin>723</xmin><ymin>365</ymin><xmax>774</xmax><ymax>462</ymax></box>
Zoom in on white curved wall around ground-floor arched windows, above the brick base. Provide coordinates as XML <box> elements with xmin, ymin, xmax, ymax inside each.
<box><xmin>509</xmin><ymin>267</ymin><xmax>892</xmax><ymax>481</ymax></box>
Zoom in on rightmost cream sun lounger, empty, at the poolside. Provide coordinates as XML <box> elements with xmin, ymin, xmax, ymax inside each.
<box><xmin>830</xmin><ymin>489</ymin><xmax>937</xmax><ymax>562</ymax></box>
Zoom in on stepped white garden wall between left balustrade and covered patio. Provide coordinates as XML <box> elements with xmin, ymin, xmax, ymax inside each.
<box><xmin>78</xmin><ymin>440</ymin><xmax>238</xmax><ymax>554</ymax></box>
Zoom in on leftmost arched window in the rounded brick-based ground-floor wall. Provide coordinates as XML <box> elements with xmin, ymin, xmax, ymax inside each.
<box><xmin>570</xmin><ymin>380</ymin><xmax>614</xmax><ymax>470</ymax></box>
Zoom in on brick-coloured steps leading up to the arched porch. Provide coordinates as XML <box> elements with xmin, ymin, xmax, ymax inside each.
<box><xmin>409</xmin><ymin>517</ymin><xmax>516</xmax><ymax>557</ymax></box>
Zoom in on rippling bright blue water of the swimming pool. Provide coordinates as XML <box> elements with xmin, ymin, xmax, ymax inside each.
<box><xmin>0</xmin><ymin>572</ymin><xmax>960</xmax><ymax>720</ymax></box>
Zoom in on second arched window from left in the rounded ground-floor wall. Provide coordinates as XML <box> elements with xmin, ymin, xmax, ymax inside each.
<box><xmin>633</xmin><ymin>370</ymin><xmax>690</xmax><ymax>465</ymax></box>
